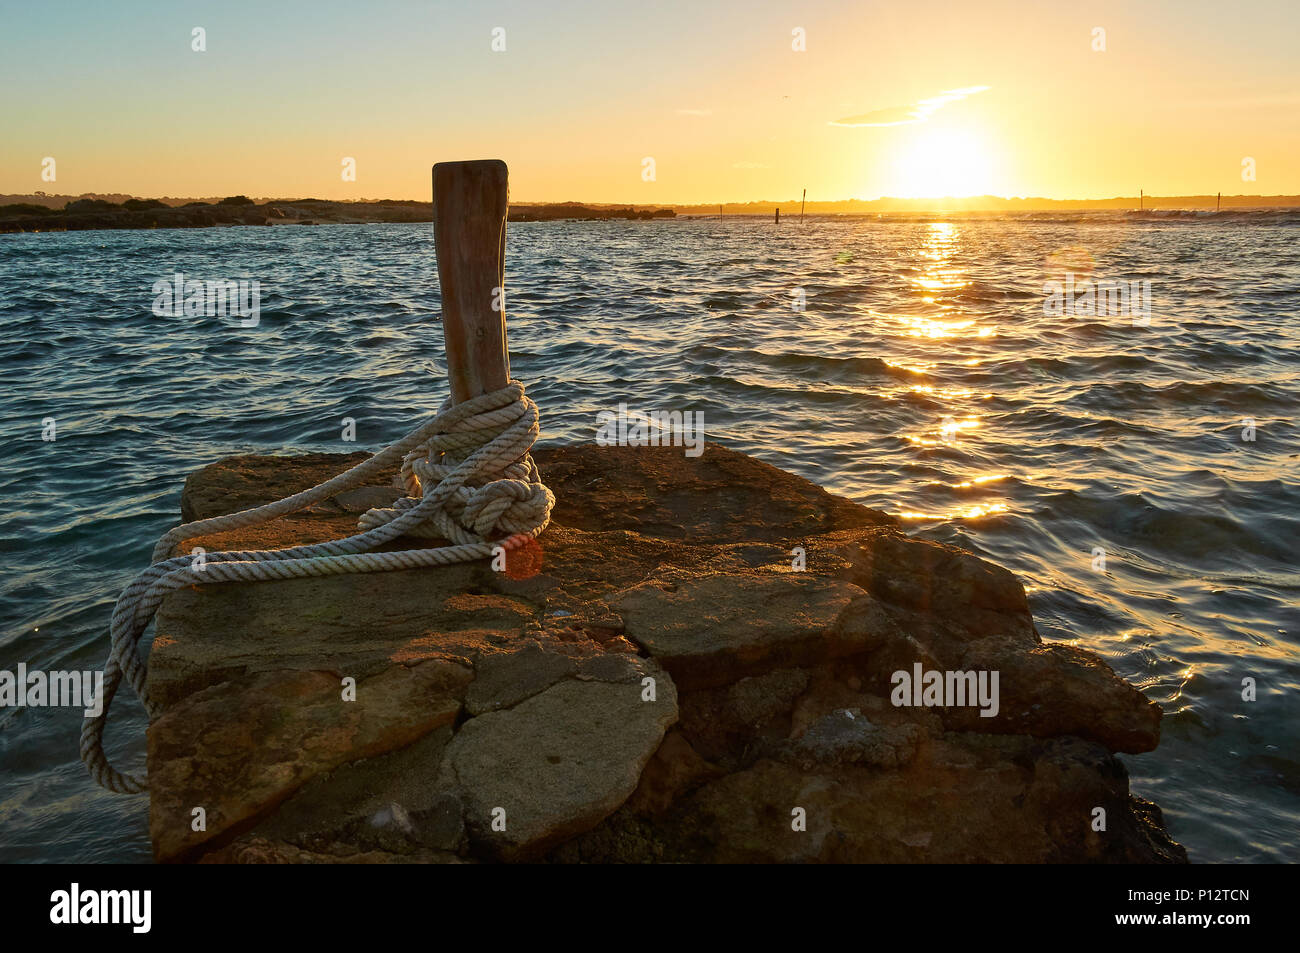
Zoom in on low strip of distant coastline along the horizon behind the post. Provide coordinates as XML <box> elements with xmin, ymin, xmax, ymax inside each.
<box><xmin>0</xmin><ymin>192</ymin><xmax>1300</xmax><ymax>233</ymax></box>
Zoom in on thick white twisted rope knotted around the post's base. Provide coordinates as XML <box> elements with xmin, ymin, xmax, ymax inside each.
<box><xmin>81</xmin><ymin>381</ymin><xmax>555</xmax><ymax>793</ymax></box>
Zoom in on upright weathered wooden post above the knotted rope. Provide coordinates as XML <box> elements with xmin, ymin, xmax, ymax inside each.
<box><xmin>433</xmin><ymin>159</ymin><xmax>510</xmax><ymax>403</ymax></box>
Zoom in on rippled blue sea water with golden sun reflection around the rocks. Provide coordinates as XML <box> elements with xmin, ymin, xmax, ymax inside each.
<box><xmin>0</xmin><ymin>215</ymin><xmax>1300</xmax><ymax>861</ymax></box>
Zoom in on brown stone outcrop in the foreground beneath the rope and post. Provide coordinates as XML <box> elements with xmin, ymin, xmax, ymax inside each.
<box><xmin>148</xmin><ymin>445</ymin><xmax>1184</xmax><ymax>863</ymax></box>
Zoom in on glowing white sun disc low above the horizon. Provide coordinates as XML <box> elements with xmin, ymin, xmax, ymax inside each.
<box><xmin>891</xmin><ymin>129</ymin><xmax>996</xmax><ymax>199</ymax></box>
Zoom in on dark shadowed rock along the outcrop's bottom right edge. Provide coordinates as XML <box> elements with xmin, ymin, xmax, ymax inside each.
<box><xmin>551</xmin><ymin>736</ymin><xmax>1182</xmax><ymax>863</ymax></box>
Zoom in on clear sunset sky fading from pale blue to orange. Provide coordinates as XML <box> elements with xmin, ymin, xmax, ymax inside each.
<box><xmin>0</xmin><ymin>0</ymin><xmax>1300</xmax><ymax>204</ymax></box>
